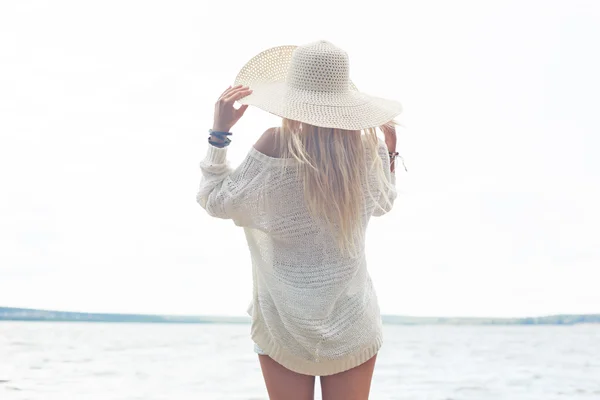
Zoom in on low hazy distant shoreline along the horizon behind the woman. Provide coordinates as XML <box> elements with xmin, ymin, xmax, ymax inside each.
<box><xmin>0</xmin><ymin>307</ymin><xmax>600</xmax><ymax>325</ymax></box>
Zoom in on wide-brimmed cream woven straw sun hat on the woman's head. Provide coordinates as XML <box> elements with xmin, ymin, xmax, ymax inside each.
<box><xmin>235</xmin><ymin>41</ymin><xmax>402</xmax><ymax>130</ymax></box>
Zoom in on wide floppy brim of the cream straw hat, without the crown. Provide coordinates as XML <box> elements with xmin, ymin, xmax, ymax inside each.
<box><xmin>235</xmin><ymin>46</ymin><xmax>402</xmax><ymax>130</ymax></box>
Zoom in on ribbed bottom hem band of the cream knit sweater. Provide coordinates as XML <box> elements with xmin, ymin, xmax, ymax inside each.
<box><xmin>251</xmin><ymin>321</ymin><xmax>383</xmax><ymax>376</ymax></box>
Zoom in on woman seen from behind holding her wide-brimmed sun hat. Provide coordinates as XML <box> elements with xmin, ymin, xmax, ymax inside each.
<box><xmin>197</xmin><ymin>41</ymin><xmax>402</xmax><ymax>400</ymax></box>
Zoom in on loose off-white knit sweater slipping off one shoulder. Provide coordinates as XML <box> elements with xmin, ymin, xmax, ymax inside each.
<box><xmin>197</xmin><ymin>139</ymin><xmax>396</xmax><ymax>376</ymax></box>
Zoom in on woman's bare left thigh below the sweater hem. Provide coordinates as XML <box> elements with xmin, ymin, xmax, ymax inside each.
<box><xmin>258</xmin><ymin>355</ymin><xmax>315</xmax><ymax>400</ymax></box>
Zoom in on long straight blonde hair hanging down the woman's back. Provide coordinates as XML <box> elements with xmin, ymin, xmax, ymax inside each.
<box><xmin>275</xmin><ymin>118</ymin><xmax>389</xmax><ymax>257</ymax></box>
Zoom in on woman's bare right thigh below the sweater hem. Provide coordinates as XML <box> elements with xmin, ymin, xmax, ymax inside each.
<box><xmin>321</xmin><ymin>355</ymin><xmax>377</xmax><ymax>400</ymax></box>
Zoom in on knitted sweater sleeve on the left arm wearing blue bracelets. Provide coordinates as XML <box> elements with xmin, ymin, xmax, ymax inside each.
<box><xmin>196</xmin><ymin>146</ymin><xmax>264</xmax><ymax>227</ymax></box>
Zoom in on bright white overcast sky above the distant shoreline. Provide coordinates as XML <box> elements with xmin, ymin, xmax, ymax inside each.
<box><xmin>0</xmin><ymin>0</ymin><xmax>600</xmax><ymax>316</ymax></box>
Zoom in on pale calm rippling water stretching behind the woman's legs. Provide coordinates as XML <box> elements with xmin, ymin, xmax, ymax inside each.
<box><xmin>0</xmin><ymin>322</ymin><xmax>600</xmax><ymax>400</ymax></box>
